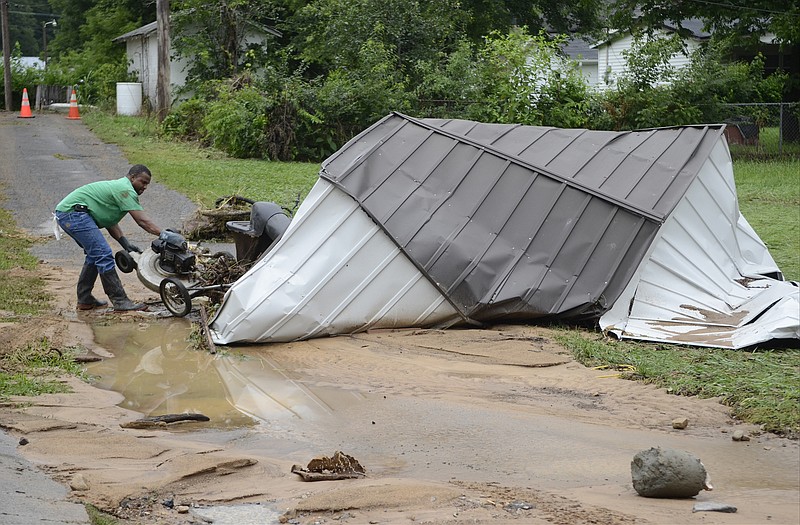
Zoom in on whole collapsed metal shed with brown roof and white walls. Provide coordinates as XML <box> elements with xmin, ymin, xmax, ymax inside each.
<box><xmin>210</xmin><ymin>113</ymin><xmax>800</xmax><ymax>348</ymax></box>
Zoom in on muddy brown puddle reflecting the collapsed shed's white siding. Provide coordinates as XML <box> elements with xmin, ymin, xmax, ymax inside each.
<box><xmin>87</xmin><ymin>319</ymin><xmax>365</xmax><ymax>429</ymax></box>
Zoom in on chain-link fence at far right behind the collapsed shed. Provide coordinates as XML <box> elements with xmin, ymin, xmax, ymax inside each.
<box><xmin>722</xmin><ymin>102</ymin><xmax>800</xmax><ymax>158</ymax></box>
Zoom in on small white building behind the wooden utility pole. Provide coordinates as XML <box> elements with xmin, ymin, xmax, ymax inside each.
<box><xmin>113</xmin><ymin>22</ymin><xmax>281</xmax><ymax>107</ymax></box>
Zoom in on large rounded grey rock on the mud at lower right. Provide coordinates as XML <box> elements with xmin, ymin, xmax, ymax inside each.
<box><xmin>631</xmin><ymin>448</ymin><xmax>710</xmax><ymax>498</ymax></box>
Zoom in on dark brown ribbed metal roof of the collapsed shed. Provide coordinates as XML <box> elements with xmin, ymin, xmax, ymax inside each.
<box><xmin>320</xmin><ymin>114</ymin><xmax>722</xmax><ymax>321</ymax></box>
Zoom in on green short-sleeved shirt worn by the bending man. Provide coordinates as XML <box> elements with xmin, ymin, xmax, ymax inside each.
<box><xmin>56</xmin><ymin>177</ymin><xmax>144</xmax><ymax>228</ymax></box>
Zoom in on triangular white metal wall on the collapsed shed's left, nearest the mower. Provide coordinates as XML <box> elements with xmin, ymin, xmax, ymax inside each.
<box><xmin>211</xmin><ymin>180</ymin><xmax>460</xmax><ymax>344</ymax></box>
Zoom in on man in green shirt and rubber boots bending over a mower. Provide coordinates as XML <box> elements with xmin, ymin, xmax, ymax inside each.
<box><xmin>55</xmin><ymin>164</ymin><xmax>161</xmax><ymax>311</ymax></box>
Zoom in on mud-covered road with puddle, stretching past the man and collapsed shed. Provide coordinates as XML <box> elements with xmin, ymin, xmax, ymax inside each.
<box><xmin>0</xmin><ymin>115</ymin><xmax>800</xmax><ymax>525</ymax></box>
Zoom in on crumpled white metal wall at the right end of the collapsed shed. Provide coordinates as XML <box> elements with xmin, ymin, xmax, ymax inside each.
<box><xmin>600</xmin><ymin>139</ymin><xmax>800</xmax><ymax>348</ymax></box>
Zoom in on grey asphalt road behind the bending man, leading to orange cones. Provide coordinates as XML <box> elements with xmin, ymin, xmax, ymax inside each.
<box><xmin>0</xmin><ymin>113</ymin><xmax>196</xmax><ymax>264</ymax></box>
